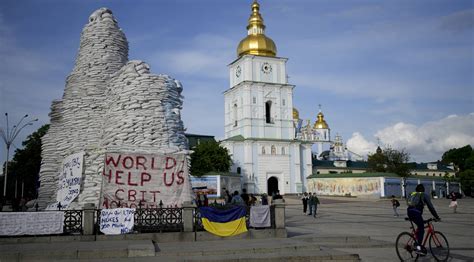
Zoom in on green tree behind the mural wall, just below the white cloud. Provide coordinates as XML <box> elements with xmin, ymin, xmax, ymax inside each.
<box><xmin>367</xmin><ymin>147</ymin><xmax>411</xmax><ymax>177</ymax></box>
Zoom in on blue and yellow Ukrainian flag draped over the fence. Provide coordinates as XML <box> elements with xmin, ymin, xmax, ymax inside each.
<box><xmin>199</xmin><ymin>206</ymin><xmax>247</xmax><ymax>237</ymax></box>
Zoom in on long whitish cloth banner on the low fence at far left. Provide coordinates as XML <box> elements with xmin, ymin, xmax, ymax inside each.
<box><xmin>0</xmin><ymin>211</ymin><xmax>64</xmax><ymax>236</ymax></box>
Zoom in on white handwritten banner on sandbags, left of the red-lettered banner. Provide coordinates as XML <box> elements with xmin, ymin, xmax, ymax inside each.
<box><xmin>46</xmin><ymin>152</ymin><xmax>84</xmax><ymax>210</ymax></box>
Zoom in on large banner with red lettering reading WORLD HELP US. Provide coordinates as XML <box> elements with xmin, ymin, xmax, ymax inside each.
<box><xmin>100</xmin><ymin>153</ymin><xmax>192</xmax><ymax>209</ymax></box>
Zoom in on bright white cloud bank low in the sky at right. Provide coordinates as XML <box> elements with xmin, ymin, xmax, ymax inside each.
<box><xmin>347</xmin><ymin>113</ymin><xmax>474</xmax><ymax>162</ymax></box>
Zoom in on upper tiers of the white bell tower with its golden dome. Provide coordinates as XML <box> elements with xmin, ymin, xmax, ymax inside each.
<box><xmin>224</xmin><ymin>2</ymin><xmax>294</xmax><ymax>139</ymax></box>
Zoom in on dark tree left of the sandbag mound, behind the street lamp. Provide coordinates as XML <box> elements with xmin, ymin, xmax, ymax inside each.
<box><xmin>7</xmin><ymin>125</ymin><xmax>49</xmax><ymax>198</ymax></box>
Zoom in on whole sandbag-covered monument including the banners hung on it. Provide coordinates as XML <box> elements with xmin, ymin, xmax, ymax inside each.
<box><xmin>37</xmin><ymin>8</ymin><xmax>192</xmax><ymax>209</ymax></box>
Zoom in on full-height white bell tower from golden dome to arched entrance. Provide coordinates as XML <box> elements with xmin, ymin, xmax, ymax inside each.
<box><xmin>221</xmin><ymin>2</ymin><xmax>330</xmax><ymax>195</ymax></box>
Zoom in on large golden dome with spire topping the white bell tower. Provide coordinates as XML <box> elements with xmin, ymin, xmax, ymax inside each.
<box><xmin>237</xmin><ymin>1</ymin><xmax>276</xmax><ymax>57</ymax></box>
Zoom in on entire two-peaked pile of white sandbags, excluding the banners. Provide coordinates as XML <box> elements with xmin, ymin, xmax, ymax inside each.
<box><xmin>38</xmin><ymin>8</ymin><xmax>188</xmax><ymax>209</ymax></box>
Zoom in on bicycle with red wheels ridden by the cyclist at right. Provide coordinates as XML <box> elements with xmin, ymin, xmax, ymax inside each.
<box><xmin>395</xmin><ymin>217</ymin><xmax>449</xmax><ymax>261</ymax></box>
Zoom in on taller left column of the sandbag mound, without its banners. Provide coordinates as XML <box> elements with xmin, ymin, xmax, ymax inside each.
<box><xmin>38</xmin><ymin>8</ymin><xmax>128</xmax><ymax>207</ymax></box>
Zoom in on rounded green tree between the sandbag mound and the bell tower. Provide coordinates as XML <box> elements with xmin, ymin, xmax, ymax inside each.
<box><xmin>190</xmin><ymin>141</ymin><xmax>232</xmax><ymax>176</ymax></box>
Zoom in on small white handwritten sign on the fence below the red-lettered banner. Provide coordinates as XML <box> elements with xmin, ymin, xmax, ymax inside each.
<box><xmin>100</xmin><ymin>208</ymin><xmax>135</xmax><ymax>235</ymax></box>
